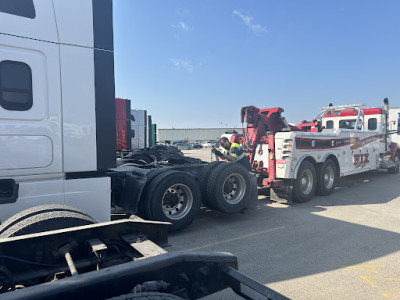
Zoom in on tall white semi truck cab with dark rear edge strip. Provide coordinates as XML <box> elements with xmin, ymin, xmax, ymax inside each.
<box><xmin>0</xmin><ymin>0</ymin><xmax>115</xmax><ymax>222</ymax></box>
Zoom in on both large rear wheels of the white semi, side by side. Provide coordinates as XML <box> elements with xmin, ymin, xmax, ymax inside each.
<box><xmin>139</xmin><ymin>162</ymin><xmax>251</xmax><ymax>231</ymax></box>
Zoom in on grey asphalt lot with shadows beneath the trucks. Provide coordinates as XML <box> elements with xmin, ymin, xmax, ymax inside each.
<box><xmin>167</xmin><ymin>149</ymin><xmax>400</xmax><ymax>299</ymax></box>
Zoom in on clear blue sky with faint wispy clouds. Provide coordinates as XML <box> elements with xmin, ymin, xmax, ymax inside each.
<box><xmin>114</xmin><ymin>0</ymin><xmax>400</xmax><ymax>128</ymax></box>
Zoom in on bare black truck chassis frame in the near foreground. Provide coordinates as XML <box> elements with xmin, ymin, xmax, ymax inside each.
<box><xmin>0</xmin><ymin>219</ymin><xmax>287</xmax><ymax>299</ymax></box>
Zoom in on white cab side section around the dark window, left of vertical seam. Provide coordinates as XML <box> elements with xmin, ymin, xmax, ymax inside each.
<box><xmin>0</xmin><ymin>0</ymin><xmax>62</xmax><ymax>177</ymax></box>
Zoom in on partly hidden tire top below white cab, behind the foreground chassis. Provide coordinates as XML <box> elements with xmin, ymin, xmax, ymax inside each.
<box><xmin>0</xmin><ymin>205</ymin><xmax>96</xmax><ymax>238</ymax></box>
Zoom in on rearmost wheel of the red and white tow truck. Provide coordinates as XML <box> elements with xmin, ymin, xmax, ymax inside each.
<box><xmin>293</xmin><ymin>160</ymin><xmax>316</xmax><ymax>203</ymax></box>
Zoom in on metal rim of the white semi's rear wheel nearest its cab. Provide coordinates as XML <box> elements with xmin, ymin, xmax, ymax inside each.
<box><xmin>162</xmin><ymin>183</ymin><xmax>193</xmax><ymax>220</ymax></box>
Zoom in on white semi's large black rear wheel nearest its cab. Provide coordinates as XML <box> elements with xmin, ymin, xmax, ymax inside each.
<box><xmin>143</xmin><ymin>171</ymin><xmax>201</xmax><ymax>231</ymax></box>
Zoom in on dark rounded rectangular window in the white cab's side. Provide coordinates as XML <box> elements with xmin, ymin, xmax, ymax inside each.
<box><xmin>0</xmin><ymin>60</ymin><xmax>33</xmax><ymax>111</ymax></box>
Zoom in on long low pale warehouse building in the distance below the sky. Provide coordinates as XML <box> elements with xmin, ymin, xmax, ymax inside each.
<box><xmin>157</xmin><ymin>128</ymin><xmax>243</xmax><ymax>143</ymax></box>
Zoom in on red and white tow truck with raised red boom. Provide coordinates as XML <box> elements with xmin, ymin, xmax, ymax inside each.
<box><xmin>231</xmin><ymin>98</ymin><xmax>400</xmax><ymax>203</ymax></box>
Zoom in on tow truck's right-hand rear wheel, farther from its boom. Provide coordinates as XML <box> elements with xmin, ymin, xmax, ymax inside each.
<box><xmin>316</xmin><ymin>159</ymin><xmax>338</xmax><ymax>196</ymax></box>
